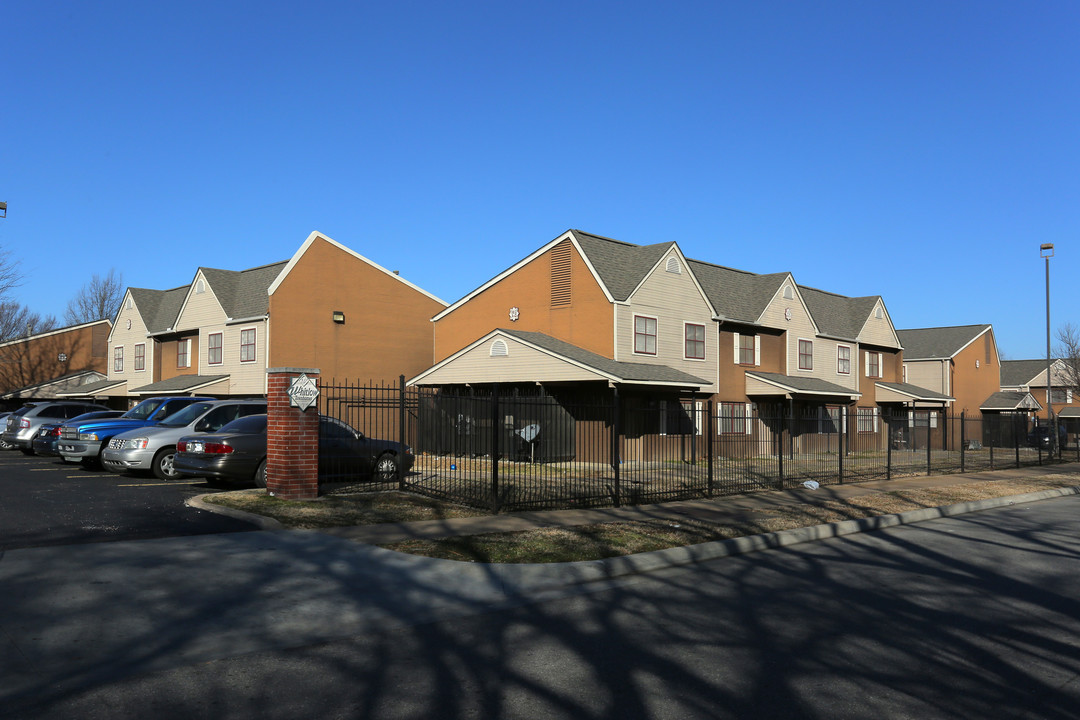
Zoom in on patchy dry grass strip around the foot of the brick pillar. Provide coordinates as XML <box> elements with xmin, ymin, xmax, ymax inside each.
<box><xmin>204</xmin><ymin>489</ymin><xmax>490</xmax><ymax>530</ymax></box>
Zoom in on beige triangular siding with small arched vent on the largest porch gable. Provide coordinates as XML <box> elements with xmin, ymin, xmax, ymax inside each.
<box><xmin>423</xmin><ymin>336</ymin><xmax>606</xmax><ymax>385</ymax></box>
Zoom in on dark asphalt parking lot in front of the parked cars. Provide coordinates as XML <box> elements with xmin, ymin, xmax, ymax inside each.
<box><xmin>0</xmin><ymin>451</ymin><xmax>256</xmax><ymax>552</ymax></box>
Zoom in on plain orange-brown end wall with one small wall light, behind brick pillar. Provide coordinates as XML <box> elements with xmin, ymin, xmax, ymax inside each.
<box><xmin>270</xmin><ymin>237</ymin><xmax>444</xmax><ymax>383</ymax></box>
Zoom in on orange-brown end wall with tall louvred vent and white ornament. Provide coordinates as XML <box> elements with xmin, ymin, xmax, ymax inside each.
<box><xmin>434</xmin><ymin>241</ymin><xmax>615</xmax><ymax>362</ymax></box>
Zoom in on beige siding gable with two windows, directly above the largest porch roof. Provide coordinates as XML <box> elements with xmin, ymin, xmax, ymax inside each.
<box><xmin>616</xmin><ymin>253</ymin><xmax>717</xmax><ymax>392</ymax></box>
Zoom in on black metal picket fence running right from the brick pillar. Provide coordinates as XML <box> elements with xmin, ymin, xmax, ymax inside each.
<box><xmin>320</xmin><ymin>384</ymin><xmax>1080</xmax><ymax>512</ymax></box>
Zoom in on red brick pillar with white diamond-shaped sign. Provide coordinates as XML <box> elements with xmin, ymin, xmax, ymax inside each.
<box><xmin>267</xmin><ymin>367</ymin><xmax>319</xmax><ymax>500</ymax></box>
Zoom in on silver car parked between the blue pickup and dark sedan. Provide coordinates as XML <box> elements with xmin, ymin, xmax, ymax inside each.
<box><xmin>102</xmin><ymin>399</ymin><xmax>267</xmax><ymax>480</ymax></box>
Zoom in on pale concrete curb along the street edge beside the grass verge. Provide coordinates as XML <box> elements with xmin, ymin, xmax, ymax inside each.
<box><xmin>486</xmin><ymin>487</ymin><xmax>1080</xmax><ymax>595</ymax></box>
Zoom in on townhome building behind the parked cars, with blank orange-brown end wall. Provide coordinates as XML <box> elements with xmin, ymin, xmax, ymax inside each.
<box><xmin>69</xmin><ymin>232</ymin><xmax>446</xmax><ymax>404</ymax></box>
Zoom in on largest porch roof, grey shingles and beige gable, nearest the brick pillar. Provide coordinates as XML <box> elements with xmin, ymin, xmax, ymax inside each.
<box><xmin>408</xmin><ymin>329</ymin><xmax>712</xmax><ymax>390</ymax></box>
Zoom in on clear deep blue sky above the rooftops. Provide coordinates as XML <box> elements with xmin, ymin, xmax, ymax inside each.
<box><xmin>0</xmin><ymin>0</ymin><xmax>1080</xmax><ymax>359</ymax></box>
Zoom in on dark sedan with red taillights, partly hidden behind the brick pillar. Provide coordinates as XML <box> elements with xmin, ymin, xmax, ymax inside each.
<box><xmin>173</xmin><ymin>415</ymin><xmax>416</xmax><ymax>488</ymax></box>
